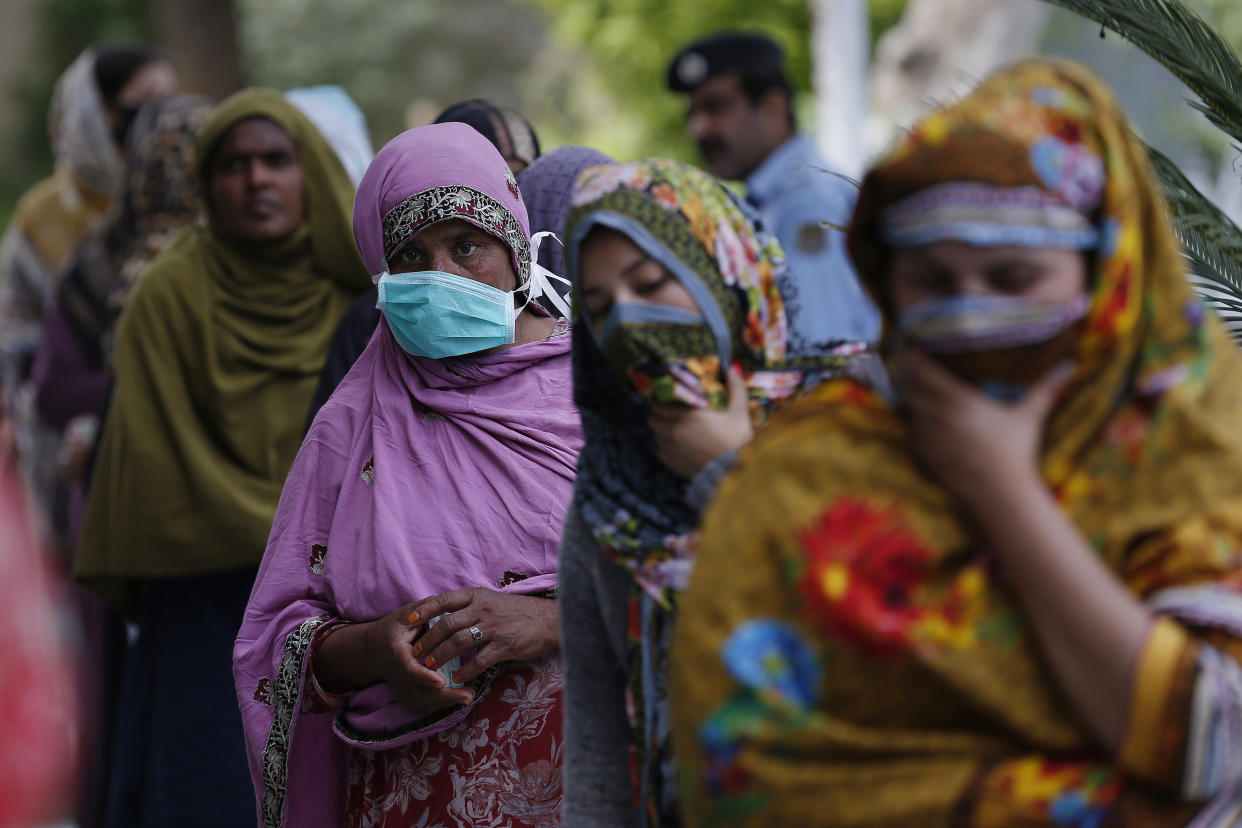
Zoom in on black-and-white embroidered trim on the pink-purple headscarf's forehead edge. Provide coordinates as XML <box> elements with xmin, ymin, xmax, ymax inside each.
<box><xmin>384</xmin><ymin>185</ymin><xmax>530</xmax><ymax>278</ymax></box>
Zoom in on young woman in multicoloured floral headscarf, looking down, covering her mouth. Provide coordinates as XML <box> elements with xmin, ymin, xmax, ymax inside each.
<box><xmin>560</xmin><ymin>160</ymin><xmax>863</xmax><ymax>826</ymax></box>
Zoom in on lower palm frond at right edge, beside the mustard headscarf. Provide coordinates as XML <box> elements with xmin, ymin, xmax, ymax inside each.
<box><xmin>1148</xmin><ymin>146</ymin><xmax>1242</xmax><ymax>338</ymax></box>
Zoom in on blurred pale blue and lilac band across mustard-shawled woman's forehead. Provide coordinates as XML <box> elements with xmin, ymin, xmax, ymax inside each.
<box><xmin>879</xmin><ymin>181</ymin><xmax>1100</xmax><ymax>250</ymax></box>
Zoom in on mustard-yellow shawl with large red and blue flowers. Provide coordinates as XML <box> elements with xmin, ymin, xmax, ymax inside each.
<box><xmin>671</xmin><ymin>61</ymin><xmax>1242</xmax><ymax>828</ymax></box>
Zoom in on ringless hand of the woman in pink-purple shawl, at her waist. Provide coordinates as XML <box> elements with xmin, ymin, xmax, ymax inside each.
<box><xmin>314</xmin><ymin>603</ymin><xmax>474</xmax><ymax>714</ymax></box>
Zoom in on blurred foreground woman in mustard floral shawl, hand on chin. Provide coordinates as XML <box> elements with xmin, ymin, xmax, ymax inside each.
<box><xmin>671</xmin><ymin>61</ymin><xmax>1242</xmax><ymax>828</ymax></box>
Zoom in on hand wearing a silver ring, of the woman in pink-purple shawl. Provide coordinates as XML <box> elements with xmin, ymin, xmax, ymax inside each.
<box><xmin>406</xmin><ymin>587</ymin><xmax>560</xmax><ymax>684</ymax></box>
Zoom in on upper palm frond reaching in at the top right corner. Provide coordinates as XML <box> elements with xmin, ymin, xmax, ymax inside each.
<box><xmin>1045</xmin><ymin>0</ymin><xmax>1242</xmax><ymax>143</ymax></box>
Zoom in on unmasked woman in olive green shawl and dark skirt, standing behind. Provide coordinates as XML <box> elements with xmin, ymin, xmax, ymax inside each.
<box><xmin>76</xmin><ymin>89</ymin><xmax>370</xmax><ymax>826</ymax></box>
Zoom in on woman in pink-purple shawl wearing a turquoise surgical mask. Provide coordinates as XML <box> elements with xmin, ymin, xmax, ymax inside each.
<box><xmin>233</xmin><ymin>124</ymin><xmax>582</xmax><ymax>828</ymax></box>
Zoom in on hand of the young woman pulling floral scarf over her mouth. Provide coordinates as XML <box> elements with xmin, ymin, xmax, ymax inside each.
<box><xmin>647</xmin><ymin>367</ymin><xmax>754</xmax><ymax>480</ymax></box>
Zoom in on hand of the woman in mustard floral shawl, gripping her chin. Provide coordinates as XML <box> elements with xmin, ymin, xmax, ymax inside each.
<box><xmin>895</xmin><ymin>348</ymin><xmax>1072</xmax><ymax>513</ymax></box>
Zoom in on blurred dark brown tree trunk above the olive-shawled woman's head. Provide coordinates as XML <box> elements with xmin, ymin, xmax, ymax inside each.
<box><xmin>152</xmin><ymin>0</ymin><xmax>242</xmax><ymax>101</ymax></box>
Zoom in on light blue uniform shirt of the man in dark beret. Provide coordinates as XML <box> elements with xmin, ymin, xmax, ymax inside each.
<box><xmin>746</xmin><ymin>135</ymin><xmax>879</xmax><ymax>354</ymax></box>
